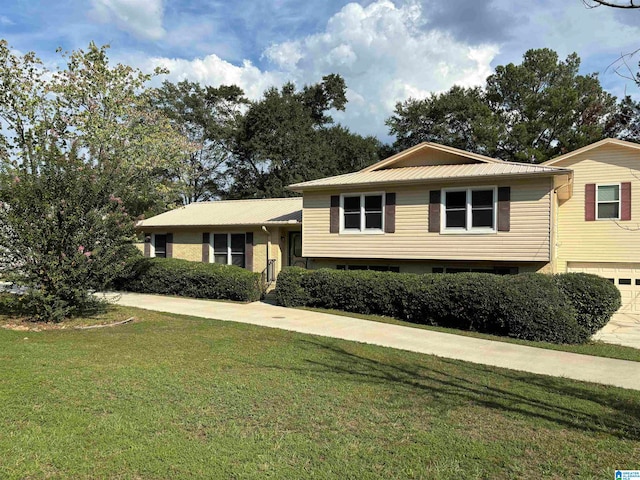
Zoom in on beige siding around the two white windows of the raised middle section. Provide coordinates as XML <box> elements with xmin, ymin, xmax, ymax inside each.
<box><xmin>302</xmin><ymin>177</ymin><xmax>552</xmax><ymax>262</ymax></box>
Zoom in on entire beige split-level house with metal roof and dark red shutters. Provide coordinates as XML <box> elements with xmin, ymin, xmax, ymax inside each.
<box><xmin>138</xmin><ymin>139</ymin><xmax>640</xmax><ymax>313</ymax></box>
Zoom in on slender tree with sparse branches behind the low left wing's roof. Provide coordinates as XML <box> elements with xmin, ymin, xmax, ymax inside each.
<box><xmin>152</xmin><ymin>81</ymin><xmax>248</xmax><ymax>204</ymax></box>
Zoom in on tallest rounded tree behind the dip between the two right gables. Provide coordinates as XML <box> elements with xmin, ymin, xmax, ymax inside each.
<box><xmin>486</xmin><ymin>48</ymin><xmax>616</xmax><ymax>163</ymax></box>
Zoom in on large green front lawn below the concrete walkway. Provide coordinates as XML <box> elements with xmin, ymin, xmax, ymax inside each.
<box><xmin>0</xmin><ymin>309</ymin><xmax>640</xmax><ymax>480</ymax></box>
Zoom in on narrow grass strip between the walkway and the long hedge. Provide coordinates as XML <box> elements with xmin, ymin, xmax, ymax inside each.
<box><xmin>298</xmin><ymin>307</ymin><xmax>640</xmax><ymax>362</ymax></box>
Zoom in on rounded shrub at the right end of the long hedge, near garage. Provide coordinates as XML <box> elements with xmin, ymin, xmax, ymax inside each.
<box><xmin>554</xmin><ymin>273</ymin><xmax>621</xmax><ymax>335</ymax></box>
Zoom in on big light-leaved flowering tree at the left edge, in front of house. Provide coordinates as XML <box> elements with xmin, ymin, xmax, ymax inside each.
<box><xmin>0</xmin><ymin>41</ymin><xmax>189</xmax><ymax>321</ymax></box>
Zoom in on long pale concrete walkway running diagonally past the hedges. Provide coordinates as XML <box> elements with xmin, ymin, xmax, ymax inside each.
<box><xmin>108</xmin><ymin>293</ymin><xmax>640</xmax><ymax>390</ymax></box>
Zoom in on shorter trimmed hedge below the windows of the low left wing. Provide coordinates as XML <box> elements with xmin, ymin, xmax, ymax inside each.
<box><xmin>113</xmin><ymin>257</ymin><xmax>264</xmax><ymax>302</ymax></box>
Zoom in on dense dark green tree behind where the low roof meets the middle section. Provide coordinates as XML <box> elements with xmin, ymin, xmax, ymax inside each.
<box><xmin>226</xmin><ymin>75</ymin><xmax>380</xmax><ymax>198</ymax></box>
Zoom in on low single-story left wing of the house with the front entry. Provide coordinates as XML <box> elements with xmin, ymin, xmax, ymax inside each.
<box><xmin>136</xmin><ymin>197</ymin><xmax>306</xmax><ymax>281</ymax></box>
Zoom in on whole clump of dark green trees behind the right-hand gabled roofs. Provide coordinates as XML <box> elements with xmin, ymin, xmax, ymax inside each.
<box><xmin>387</xmin><ymin>49</ymin><xmax>623</xmax><ymax>163</ymax></box>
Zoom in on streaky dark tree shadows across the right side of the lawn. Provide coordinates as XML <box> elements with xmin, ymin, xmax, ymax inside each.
<box><xmin>256</xmin><ymin>340</ymin><xmax>640</xmax><ymax>440</ymax></box>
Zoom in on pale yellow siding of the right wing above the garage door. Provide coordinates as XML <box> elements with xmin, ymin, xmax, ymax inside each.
<box><xmin>554</xmin><ymin>144</ymin><xmax>640</xmax><ymax>272</ymax></box>
